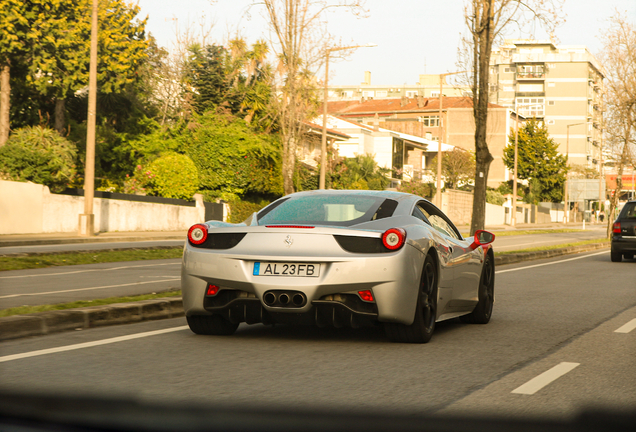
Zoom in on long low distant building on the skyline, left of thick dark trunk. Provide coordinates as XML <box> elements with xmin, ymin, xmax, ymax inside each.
<box><xmin>328</xmin><ymin>71</ymin><xmax>470</xmax><ymax>101</ymax></box>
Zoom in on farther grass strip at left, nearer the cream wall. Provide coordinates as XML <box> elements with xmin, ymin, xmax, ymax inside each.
<box><xmin>0</xmin><ymin>247</ymin><xmax>183</xmax><ymax>271</ymax></box>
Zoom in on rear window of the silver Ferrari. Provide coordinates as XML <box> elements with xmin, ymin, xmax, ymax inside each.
<box><xmin>258</xmin><ymin>194</ymin><xmax>398</xmax><ymax>226</ymax></box>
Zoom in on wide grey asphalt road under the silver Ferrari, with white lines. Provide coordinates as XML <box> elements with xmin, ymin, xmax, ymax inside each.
<box><xmin>0</xmin><ymin>250</ymin><xmax>636</xmax><ymax>418</ymax></box>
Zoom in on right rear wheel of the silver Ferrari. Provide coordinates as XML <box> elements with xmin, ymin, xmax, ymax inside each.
<box><xmin>384</xmin><ymin>255</ymin><xmax>437</xmax><ymax>343</ymax></box>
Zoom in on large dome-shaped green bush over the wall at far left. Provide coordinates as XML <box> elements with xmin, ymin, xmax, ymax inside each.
<box><xmin>0</xmin><ymin>126</ymin><xmax>77</xmax><ymax>192</ymax></box>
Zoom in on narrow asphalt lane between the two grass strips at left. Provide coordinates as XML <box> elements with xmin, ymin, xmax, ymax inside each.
<box><xmin>0</xmin><ymin>259</ymin><xmax>181</xmax><ymax>309</ymax></box>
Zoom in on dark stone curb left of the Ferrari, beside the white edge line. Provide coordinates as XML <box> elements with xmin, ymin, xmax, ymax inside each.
<box><xmin>0</xmin><ymin>297</ymin><xmax>184</xmax><ymax>341</ymax></box>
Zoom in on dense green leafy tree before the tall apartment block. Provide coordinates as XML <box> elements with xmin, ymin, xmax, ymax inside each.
<box><xmin>503</xmin><ymin>118</ymin><xmax>568</xmax><ymax>204</ymax></box>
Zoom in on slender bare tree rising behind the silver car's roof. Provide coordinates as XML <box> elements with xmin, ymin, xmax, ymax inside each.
<box><xmin>254</xmin><ymin>0</ymin><xmax>365</xmax><ymax>194</ymax></box>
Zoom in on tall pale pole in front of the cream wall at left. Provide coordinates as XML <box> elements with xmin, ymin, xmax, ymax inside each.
<box><xmin>79</xmin><ymin>0</ymin><xmax>99</xmax><ymax>237</ymax></box>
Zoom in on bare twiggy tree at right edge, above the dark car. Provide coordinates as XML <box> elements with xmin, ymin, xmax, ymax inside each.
<box><xmin>600</xmin><ymin>13</ymin><xmax>636</xmax><ymax>237</ymax></box>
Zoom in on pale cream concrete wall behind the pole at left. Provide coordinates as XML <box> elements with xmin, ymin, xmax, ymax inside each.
<box><xmin>0</xmin><ymin>181</ymin><xmax>205</xmax><ymax>234</ymax></box>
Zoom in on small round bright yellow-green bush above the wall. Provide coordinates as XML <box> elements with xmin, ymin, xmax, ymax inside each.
<box><xmin>146</xmin><ymin>153</ymin><xmax>199</xmax><ymax>200</ymax></box>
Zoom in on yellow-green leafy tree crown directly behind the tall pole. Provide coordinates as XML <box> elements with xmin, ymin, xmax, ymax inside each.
<box><xmin>29</xmin><ymin>0</ymin><xmax>148</xmax><ymax>133</ymax></box>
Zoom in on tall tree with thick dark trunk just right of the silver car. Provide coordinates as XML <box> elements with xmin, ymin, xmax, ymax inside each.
<box><xmin>460</xmin><ymin>0</ymin><xmax>563</xmax><ymax>234</ymax></box>
